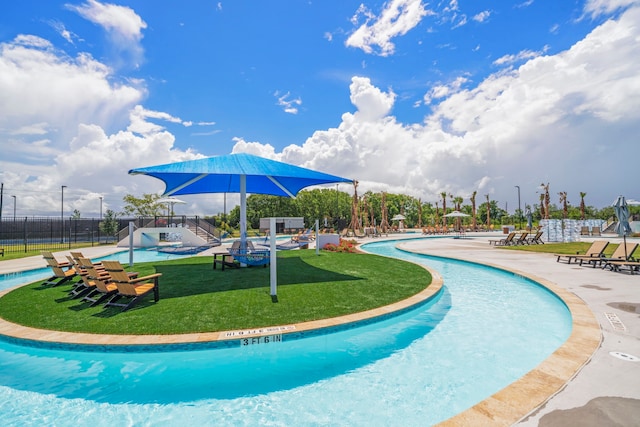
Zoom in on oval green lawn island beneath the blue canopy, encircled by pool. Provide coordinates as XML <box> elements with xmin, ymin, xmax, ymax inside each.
<box><xmin>0</xmin><ymin>249</ymin><xmax>431</xmax><ymax>334</ymax></box>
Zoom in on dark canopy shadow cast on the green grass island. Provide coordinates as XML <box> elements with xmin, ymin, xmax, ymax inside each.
<box><xmin>155</xmin><ymin>257</ymin><xmax>362</xmax><ymax>299</ymax></box>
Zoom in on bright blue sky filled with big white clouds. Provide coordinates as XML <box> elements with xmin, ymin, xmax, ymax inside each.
<box><xmin>0</xmin><ymin>0</ymin><xmax>640</xmax><ymax>216</ymax></box>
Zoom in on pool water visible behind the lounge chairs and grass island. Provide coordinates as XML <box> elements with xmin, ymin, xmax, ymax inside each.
<box><xmin>0</xmin><ymin>249</ymin><xmax>193</xmax><ymax>290</ymax></box>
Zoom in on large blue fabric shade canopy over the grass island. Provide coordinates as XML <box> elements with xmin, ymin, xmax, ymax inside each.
<box><xmin>129</xmin><ymin>153</ymin><xmax>353</xmax><ymax>197</ymax></box>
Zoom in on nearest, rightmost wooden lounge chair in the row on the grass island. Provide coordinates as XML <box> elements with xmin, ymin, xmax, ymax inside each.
<box><xmin>102</xmin><ymin>261</ymin><xmax>162</xmax><ymax>311</ymax></box>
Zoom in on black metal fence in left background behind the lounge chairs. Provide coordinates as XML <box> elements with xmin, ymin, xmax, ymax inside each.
<box><xmin>0</xmin><ymin>216</ymin><xmax>220</xmax><ymax>253</ymax></box>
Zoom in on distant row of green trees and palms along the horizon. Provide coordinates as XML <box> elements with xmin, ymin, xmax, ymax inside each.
<box><xmin>216</xmin><ymin>183</ymin><xmax>613</xmax><ymax>230</ymax></box>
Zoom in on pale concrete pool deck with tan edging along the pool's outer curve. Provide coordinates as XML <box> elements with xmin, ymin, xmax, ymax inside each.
<box><xmin>0</xmin><ymin>233</ymin><xmax>640</xmax><ymax>426</ymax></box>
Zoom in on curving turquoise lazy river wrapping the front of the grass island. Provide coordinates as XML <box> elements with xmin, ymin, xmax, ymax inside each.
<box><xmin>0</xmin><ymin>242</ymin><xmax>571</xmax><ymax>426</ymax></box>
